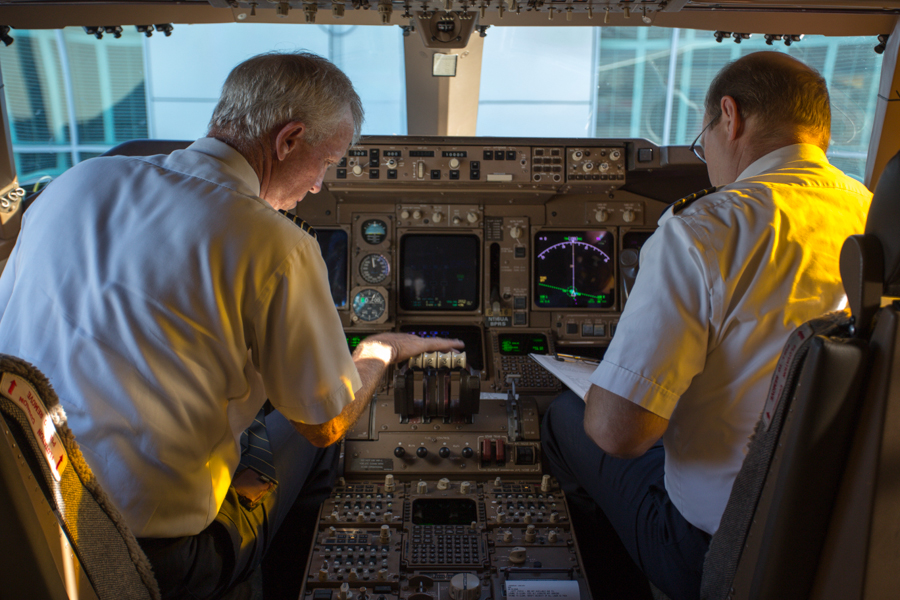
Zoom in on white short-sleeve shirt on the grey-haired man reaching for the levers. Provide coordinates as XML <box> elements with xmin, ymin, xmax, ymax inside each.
<box><xmin>0</xmin><ymin>138</ymin><xmax>361</xmax><ymax>537</ymax></box>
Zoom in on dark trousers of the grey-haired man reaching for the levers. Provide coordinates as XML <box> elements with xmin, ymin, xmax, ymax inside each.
<box><xmin>138</xmin><ymin>412</ymin><xmax>340</xmax><ymax>599</ymax></box>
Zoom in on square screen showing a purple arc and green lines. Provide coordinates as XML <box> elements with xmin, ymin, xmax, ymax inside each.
<box><xmin>534</xmin><ymin>229</ymin><xmax>616</xmax><ymax>309</ymax></box>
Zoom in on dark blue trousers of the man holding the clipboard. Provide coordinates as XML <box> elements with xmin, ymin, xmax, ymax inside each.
<box><xmin>541</xmin><ymin>391</ymin><xmax>710</xmax><ymax>600</ymax></box>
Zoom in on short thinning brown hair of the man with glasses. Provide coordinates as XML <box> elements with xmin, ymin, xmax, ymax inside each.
<box><xmin>706</xmin><ymin>52</ymin><xmax>831</xmax><ymax>150</ymax></box>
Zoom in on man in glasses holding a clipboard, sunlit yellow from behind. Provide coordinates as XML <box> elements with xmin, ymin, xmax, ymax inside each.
<box><xmin>542</xmin><ymin>52</ymin><xmax>872</xmax><ymax>600</ymax></box>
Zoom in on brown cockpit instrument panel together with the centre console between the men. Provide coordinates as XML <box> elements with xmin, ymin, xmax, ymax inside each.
<box><xmin>288</xmin><ymin>137</ymin><xmax>707</xmax><ymax>600</ymax></box>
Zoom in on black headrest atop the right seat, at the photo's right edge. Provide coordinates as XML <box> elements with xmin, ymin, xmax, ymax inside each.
<box><xmin>866</xmin><ymin>152</ymin><xmax>900</xmax><ymax>296</ymax></box>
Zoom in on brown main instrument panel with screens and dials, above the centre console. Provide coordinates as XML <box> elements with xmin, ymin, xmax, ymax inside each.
<box><xmin>296</xmin><ymin>137</ymin><xmax>707</xmax><ymax>394</ymax></box>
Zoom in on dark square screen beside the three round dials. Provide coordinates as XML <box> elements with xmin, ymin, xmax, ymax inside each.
<box><xmin>400</xmin><ymin>234</ymin><xmax>481</xmax><ymax>312</ymax></box>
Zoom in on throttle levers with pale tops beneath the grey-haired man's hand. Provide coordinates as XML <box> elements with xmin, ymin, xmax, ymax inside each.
<box><xmin>394</xmin><ymin>352</ymin><xmax>481</xmax><ymax>423</ymax></box>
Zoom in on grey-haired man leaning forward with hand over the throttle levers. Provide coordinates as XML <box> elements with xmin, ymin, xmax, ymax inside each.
<box><xmin>0</xmin><ymin>53</ymin><xmax>462</xmax><ymax>598</ymax></box>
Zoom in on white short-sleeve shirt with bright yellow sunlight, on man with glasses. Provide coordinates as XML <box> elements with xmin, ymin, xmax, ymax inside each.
<box><xmin>591</xmin><ymin>144</ymin><xmax>872</xmax><ymax>534</ymax></box>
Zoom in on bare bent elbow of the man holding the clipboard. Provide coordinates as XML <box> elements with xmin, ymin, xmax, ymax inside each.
<box><xmin>584</xmin><ymin>385</ymin><xmax>669</xmax><ymax>458</ymax></box>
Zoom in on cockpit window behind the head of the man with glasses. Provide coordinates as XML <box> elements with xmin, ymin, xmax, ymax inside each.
<box><xmin>477</xmin><ymin>27</ymin><xmax>882</xmax><ymax>180</ymax></box>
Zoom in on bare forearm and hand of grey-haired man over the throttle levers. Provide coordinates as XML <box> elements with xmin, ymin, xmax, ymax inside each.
<box><xmin>291</xmin><ymin>333</ymin><xmax>464</xmax><ymax>448</ymax></box>
